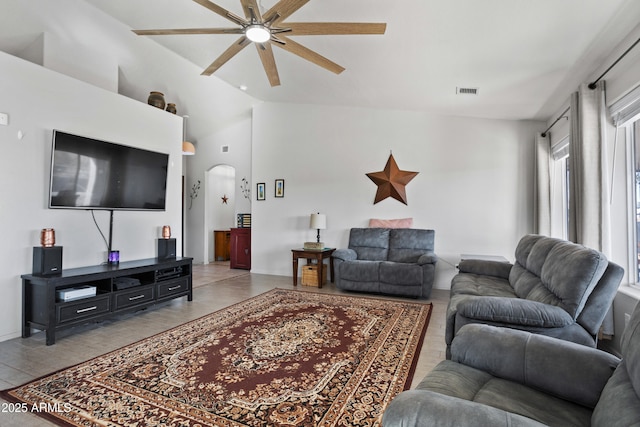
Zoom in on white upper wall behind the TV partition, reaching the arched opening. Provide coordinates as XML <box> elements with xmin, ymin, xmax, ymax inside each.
<box><xmin>0</xmin><ymin>0</ymin><xmax>257</xmax><ymax>263</ymax></box>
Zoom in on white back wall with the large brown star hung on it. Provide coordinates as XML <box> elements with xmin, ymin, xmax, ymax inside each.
<box><xmin>252</xmin><ymin>104</ymin><xmax>544</xmax><ymax>288</ymax></box>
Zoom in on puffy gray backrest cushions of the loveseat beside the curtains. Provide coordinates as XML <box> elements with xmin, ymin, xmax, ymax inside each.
<box><xmin>509</xmin><ymin>235</ymin><xmax>608</xmax><ymax>319</ymax></box>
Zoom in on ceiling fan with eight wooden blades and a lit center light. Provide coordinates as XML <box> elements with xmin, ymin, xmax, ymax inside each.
<box><xmin>133</xmin><ymin>0</ymin><xmax>387</xmax><ymax>86</ymax></box>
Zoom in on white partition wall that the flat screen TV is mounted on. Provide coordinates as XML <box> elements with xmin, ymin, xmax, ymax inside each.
<box><xmin>0</xmin><ymin>52</ymin><xmax>182</xmax><ymax>341</ymax></box>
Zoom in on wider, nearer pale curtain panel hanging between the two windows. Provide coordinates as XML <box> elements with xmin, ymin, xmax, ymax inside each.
<box><xmin>569</xmin><ymin>81</ymin><xmax>613</xmax><ymax>335</ymax></box>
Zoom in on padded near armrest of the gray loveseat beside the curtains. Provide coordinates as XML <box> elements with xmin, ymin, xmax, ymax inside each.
<box><xmin>457</xmin><ymin>296</ymin><xmax>575</xmax><ymax>328</ymax></box>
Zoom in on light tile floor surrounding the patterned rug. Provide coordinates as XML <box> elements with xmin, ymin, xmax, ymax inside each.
<box><xmin>0</xmin><ymin>262</ymin><xmax>449</xmax><ymax>427</ymax></box>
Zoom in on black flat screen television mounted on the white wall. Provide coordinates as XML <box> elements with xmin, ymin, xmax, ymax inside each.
<box><xmin>49</xmin><ymin>130</ymin><xmax>169</xmax><ymax>211</ymax></box>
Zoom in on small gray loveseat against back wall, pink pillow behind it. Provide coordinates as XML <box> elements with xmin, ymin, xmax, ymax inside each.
<box><xmin>333</xmin><ymin>228</ymin><xmax>438</xmax><ymax>298</ymax></box>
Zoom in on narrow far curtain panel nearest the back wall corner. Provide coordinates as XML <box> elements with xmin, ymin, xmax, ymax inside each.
<box><xmin>534</xmin><ymin>133</ymin><xmax>551</xmax><ymax>236</ymax></box>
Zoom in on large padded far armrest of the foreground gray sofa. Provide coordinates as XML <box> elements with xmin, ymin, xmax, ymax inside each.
<box><xmin>451</xmin><ymin>324</ymin><xmax>620</xmax><ymax>408</ymax></box>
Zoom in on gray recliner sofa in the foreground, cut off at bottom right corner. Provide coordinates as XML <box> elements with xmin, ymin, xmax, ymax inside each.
<box><xmin>382</xmin><ymin>304</ymin><xmax>640</xmax><ymax>427</ymax></box>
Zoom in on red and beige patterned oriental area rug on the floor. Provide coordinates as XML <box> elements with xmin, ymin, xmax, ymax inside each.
<box><xmin>2</xmin><ymin>289</ymin><xmax>431</xmax><ymax>427</ymax></box>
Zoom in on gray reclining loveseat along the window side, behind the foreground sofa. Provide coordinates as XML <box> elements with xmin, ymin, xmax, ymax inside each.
<box><xmin>445</xmin><ymin>235</ymin><xmax>624</xmax><ymax>358</ymax></box>
